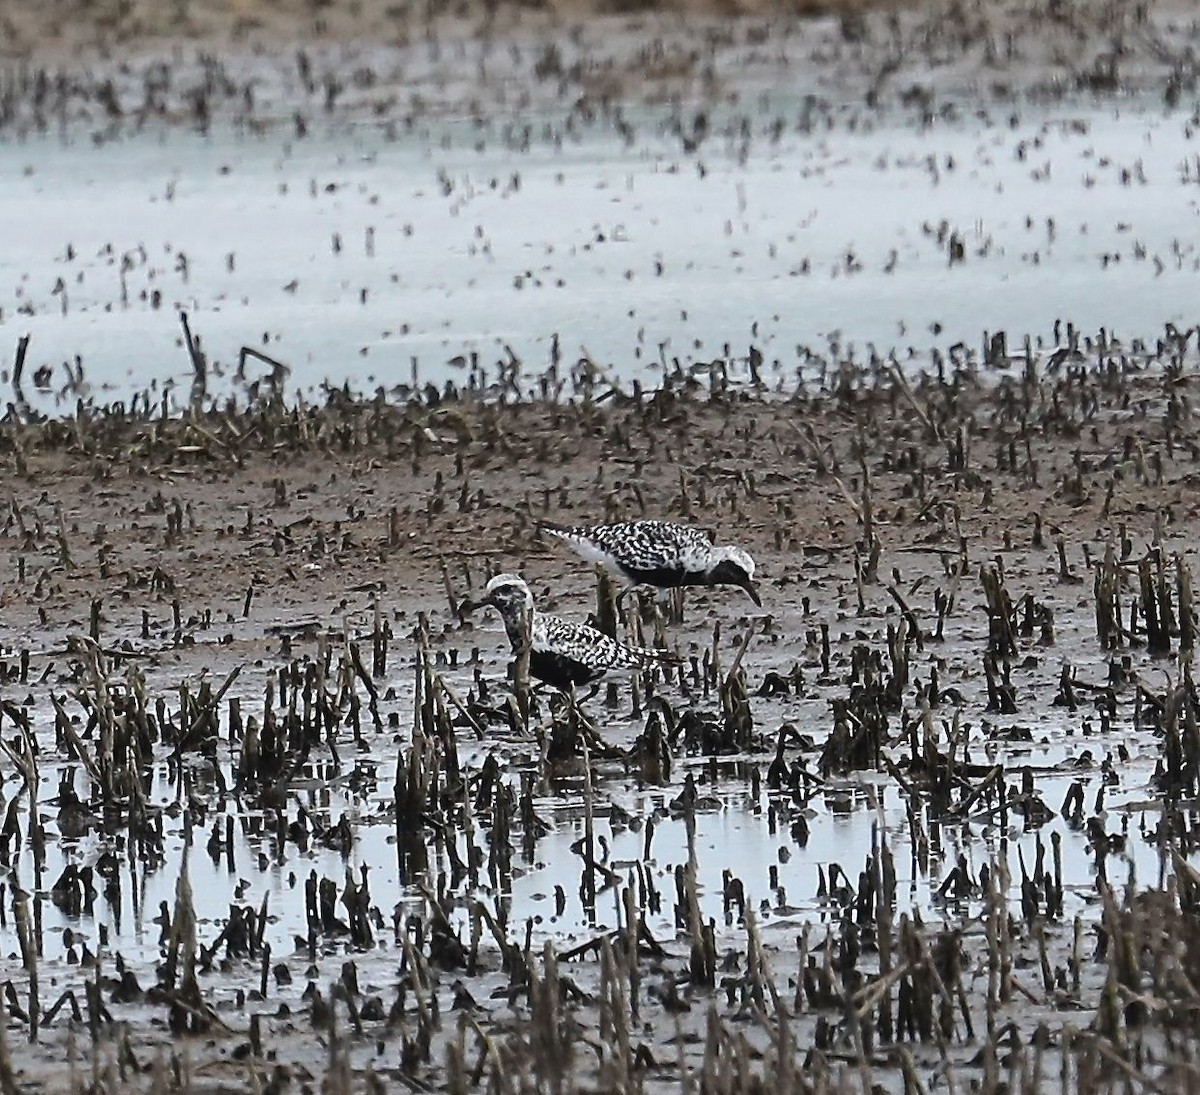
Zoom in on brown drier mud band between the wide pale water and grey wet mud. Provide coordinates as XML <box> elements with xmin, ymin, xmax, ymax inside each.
<box><xmin>2</xmin><ymin>355</ymin><xmax>1200</xmax><ymax>640</ymax></box>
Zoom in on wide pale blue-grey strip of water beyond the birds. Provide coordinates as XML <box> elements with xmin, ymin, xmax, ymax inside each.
<box><xmin>0</xmin><ymin>92</ymin><xmax>1200</xmax><ymax>409</ymax></box>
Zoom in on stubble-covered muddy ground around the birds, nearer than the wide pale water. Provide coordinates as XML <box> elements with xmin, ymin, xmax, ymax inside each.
<box><xmin>0</xmin><ymin>352</ymin><xmax>1200</xmax><ymax>1091</ymax></box>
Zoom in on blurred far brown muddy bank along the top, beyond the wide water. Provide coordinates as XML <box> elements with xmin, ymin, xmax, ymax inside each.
<box><xmin>0</xmin><ymin>0</ymin><xmax>1200</xmax><ymax>130</ymax></box>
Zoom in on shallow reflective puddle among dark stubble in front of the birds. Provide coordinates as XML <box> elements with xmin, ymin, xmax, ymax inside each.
<box><xmin>7</xmin><ymin>686</ymin><xmax>1160</xmax><ymax>979</ymax></box>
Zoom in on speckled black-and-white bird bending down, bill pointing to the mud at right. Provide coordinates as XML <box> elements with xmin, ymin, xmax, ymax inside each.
<box><xmin>541</xmin><ymin>521</ymin><xmax>762</xmax><ymax>608</ymax></box>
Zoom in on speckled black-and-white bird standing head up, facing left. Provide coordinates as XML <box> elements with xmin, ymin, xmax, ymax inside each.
<box><xmin>463</xmin><ymin>574</ymin><xmax>676</xmax><ymax>690</ymax></box>
